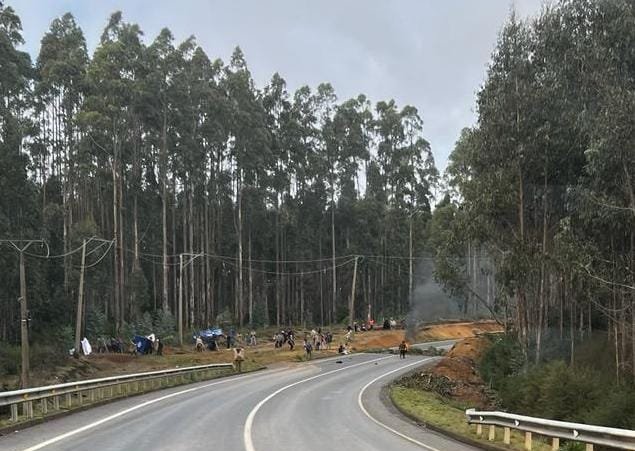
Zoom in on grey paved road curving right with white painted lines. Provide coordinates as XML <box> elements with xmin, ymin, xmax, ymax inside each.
<box><xmin>0</xmin><ymin>354</ymin><xmax>475</xmax><ymax>451</ymax></box>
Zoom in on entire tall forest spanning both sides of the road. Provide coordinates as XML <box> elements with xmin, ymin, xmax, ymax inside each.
<box><xmin>0</xmin><ymin>0</ymin><xmax>635</xmax><ymax>394</ymax></box>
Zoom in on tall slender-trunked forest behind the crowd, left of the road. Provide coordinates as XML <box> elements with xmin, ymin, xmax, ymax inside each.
<box><xmin>0</xmin><ymin>0</ymin><xmax>438</xmax><ymax>350</ymax></box>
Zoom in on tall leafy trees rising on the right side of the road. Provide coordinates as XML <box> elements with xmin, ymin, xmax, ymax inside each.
<box><xmin>430</xmin><ymin>0</ymin><xmax>635</xmax><ymax>382</ymax></box>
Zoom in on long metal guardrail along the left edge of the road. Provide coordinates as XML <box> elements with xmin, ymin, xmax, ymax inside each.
<box><xmin>0</xmin><ymin>363</ymin><xmax>233</xmax><ymax>422</ymax></box>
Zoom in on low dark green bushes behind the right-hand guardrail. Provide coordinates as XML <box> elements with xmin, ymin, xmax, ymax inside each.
<box><xmin>479</xmin><ymin>336</ymin><xmax>635</xmax><ymax>429</ymax></box>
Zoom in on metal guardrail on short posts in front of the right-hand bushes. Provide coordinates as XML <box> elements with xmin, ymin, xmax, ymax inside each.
<box><xmin>465</xmin><ymin>409</ymin><xmax>635</xmax><ymax>451</ymax></box>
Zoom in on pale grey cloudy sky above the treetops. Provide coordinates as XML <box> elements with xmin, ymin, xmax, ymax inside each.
<box><xmin>11</xmin><ymin>0</ymin><xmax>541</xmax><ymax>173</ymax></box>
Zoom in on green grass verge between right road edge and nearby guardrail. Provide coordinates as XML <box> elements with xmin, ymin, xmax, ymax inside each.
<box><xmin>390</xmin><ymin>385</ymin><xmax>551</xmax><ymax>451</ymax></box>
